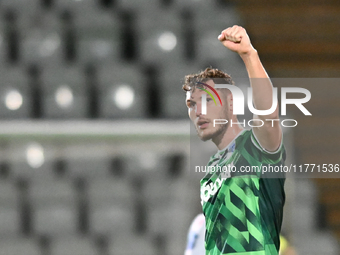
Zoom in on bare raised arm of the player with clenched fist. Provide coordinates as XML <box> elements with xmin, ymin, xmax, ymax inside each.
<box><xmin>218</xmin><ymin>26</ymin><xmax>282</xmax><ymax>151</ymax></box>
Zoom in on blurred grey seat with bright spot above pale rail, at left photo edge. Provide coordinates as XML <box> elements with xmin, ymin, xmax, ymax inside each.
<box><xmin>0</xmin><ymin>67</ymin><xmax>32</xmax><ymax>119</ymax></box>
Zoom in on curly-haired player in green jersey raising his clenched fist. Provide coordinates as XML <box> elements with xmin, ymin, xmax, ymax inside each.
<box><xmin>183</xmin><ymin>26</ymin><xmax>285</xmax><ymax>255</ymax></box>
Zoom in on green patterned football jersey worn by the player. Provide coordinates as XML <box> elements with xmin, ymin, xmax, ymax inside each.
<box><xmin>201</xmin><ymin>130</ymin><xmax>286</xmax><ymax>255</ymax></box>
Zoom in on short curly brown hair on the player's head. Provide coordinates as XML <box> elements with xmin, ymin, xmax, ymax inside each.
<box><xmin>182</xmin><ymin>67</ymin><xmax>234</xmax><ymax>91</ymax></box>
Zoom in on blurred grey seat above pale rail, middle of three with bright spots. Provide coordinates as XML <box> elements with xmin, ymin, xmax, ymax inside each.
<box><xmin>42</xmin><ymin>65</ymin><xmax>89</xmax><ymax>118</ymax></box>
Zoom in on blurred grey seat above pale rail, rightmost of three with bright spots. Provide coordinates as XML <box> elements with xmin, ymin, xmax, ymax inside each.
<box><xmin>97</xmin><ymin>62</ymin><xmax>148</xmax><ymax>119</ymax></box>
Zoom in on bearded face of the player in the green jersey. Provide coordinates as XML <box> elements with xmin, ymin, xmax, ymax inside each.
<box><xmin>186</xmin><ymin>80</ymin><xmax>230</xmax><ymax>141</ymax></box>
